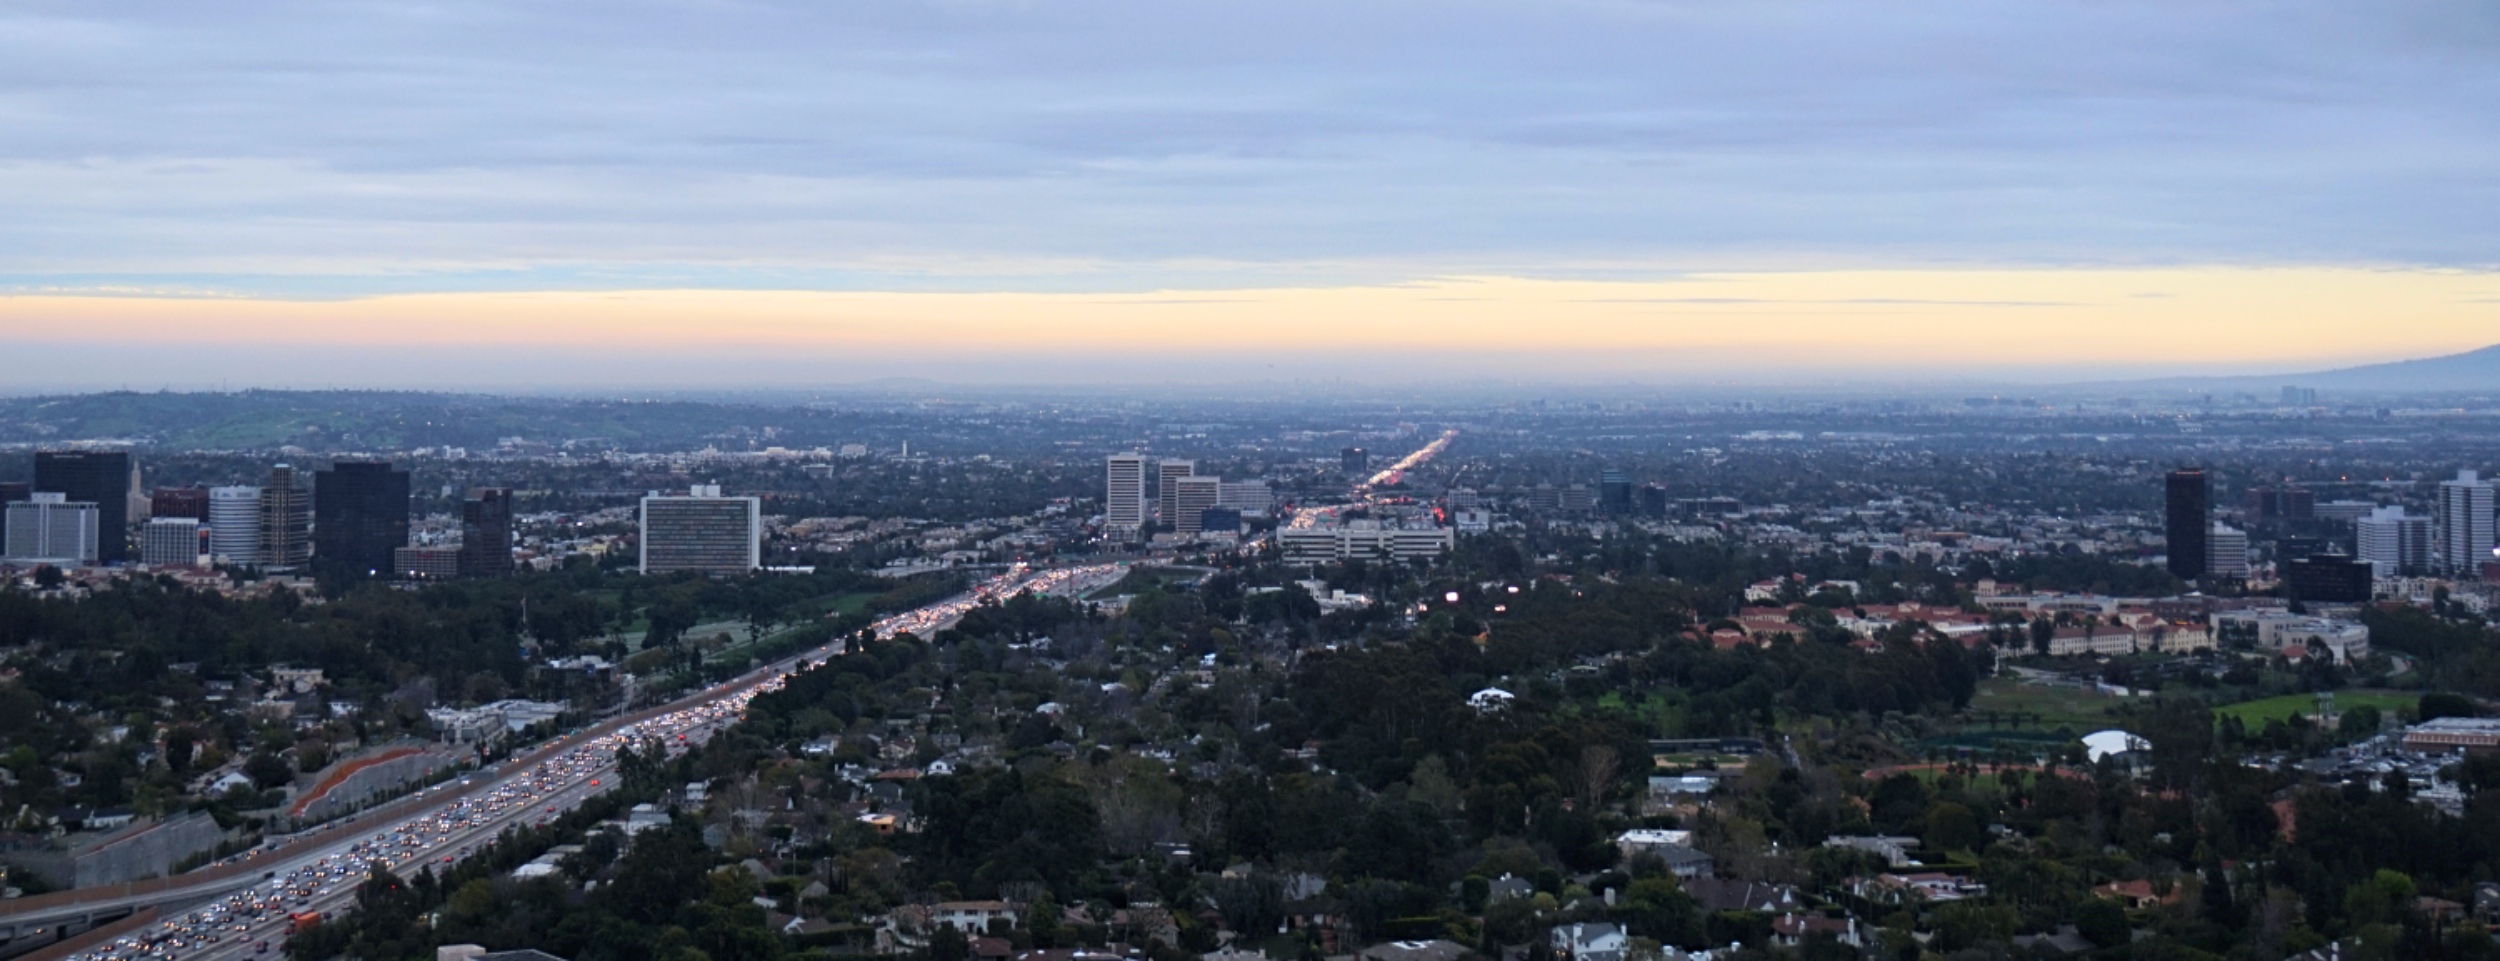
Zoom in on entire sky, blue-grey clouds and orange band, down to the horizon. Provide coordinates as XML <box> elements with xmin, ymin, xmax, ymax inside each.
<box><xmin>0</xmin><ymin>0</ymin><xmax>2500</xmax><ymax>390</ymax></box>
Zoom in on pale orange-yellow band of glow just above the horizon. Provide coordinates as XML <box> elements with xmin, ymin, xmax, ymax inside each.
<box><xmin>0</xmin><ymin>268</ymin><xmax>2500</xmax><ymax>368</ymax></box>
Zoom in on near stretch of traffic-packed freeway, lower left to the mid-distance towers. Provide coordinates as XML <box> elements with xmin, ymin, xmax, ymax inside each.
<box><xmin>0</xmin><ymin>563</ymin><xmax>1128</xmax><ymax>961</ymax></box>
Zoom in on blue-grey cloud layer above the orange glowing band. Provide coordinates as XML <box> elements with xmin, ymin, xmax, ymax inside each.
<box><xmin>0</xmin><ymin>0</ymin><xmax>2500</xmax><ymax>295</ymax></box>
